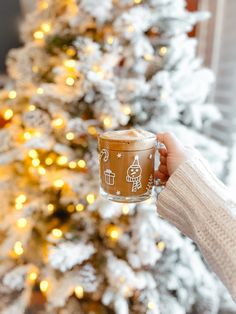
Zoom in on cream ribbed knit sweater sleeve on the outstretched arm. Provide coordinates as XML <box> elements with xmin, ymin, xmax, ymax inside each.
<box><xmin>157</xmin><ymin>156</ymin><xmax>236</xmax><ymax>300</ymax></box>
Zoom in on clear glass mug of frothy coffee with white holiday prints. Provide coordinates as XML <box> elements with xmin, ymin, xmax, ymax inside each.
<box><xmin>98</xmin><ymin>129</ymin><xmax>162</xmax><ymax>203</ymax></box>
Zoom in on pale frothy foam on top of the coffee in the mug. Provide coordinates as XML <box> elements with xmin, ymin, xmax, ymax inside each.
<box><xmin>101</xmin><ymin>129</ymin><xmax>155</xmax><ymax>140</ymax></box>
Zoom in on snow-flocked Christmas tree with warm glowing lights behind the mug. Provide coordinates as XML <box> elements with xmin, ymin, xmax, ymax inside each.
<box><xmin>0</xmin><ymin>0</ymin><xmax>236</xmax><ymax>314</ymax></box>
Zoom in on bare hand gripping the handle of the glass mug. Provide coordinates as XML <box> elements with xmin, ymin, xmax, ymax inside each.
<box><xmin>156</xmin><ymin>133</ymin><xmax>195</xmax><ymax>183</ymax></box>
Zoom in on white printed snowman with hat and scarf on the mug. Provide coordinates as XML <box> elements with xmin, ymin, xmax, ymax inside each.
<box><xmin>126</xmin><ymin>155</ymin><xmax>142</xmax><ymax>192</ymax></box>
